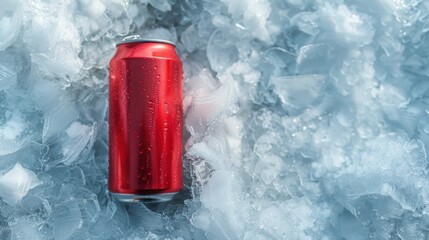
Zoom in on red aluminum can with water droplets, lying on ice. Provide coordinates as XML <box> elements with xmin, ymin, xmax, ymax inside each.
<box><xmin>109</xmin><ymin>39</ymin><xmax>183</xmax><ymax>202</ymax></box>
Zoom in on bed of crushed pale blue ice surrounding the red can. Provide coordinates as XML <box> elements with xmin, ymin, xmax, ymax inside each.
<box><xmin>0</xmin><ymin>0</ymin><xmax>429</xmax><ymax>240</ymax></box>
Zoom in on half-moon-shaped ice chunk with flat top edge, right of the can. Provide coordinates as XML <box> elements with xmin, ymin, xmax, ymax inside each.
<box><xmin>270</xmin><ymin>74</ymin><xmax>327</xmax><ymax>109</ymax></box>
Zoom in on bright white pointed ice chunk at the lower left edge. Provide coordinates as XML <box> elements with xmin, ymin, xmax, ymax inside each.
<box><xmin>0</xmin><ymin>163</ymin><xmax>42</xmax><ymax>205</ymax></box>
